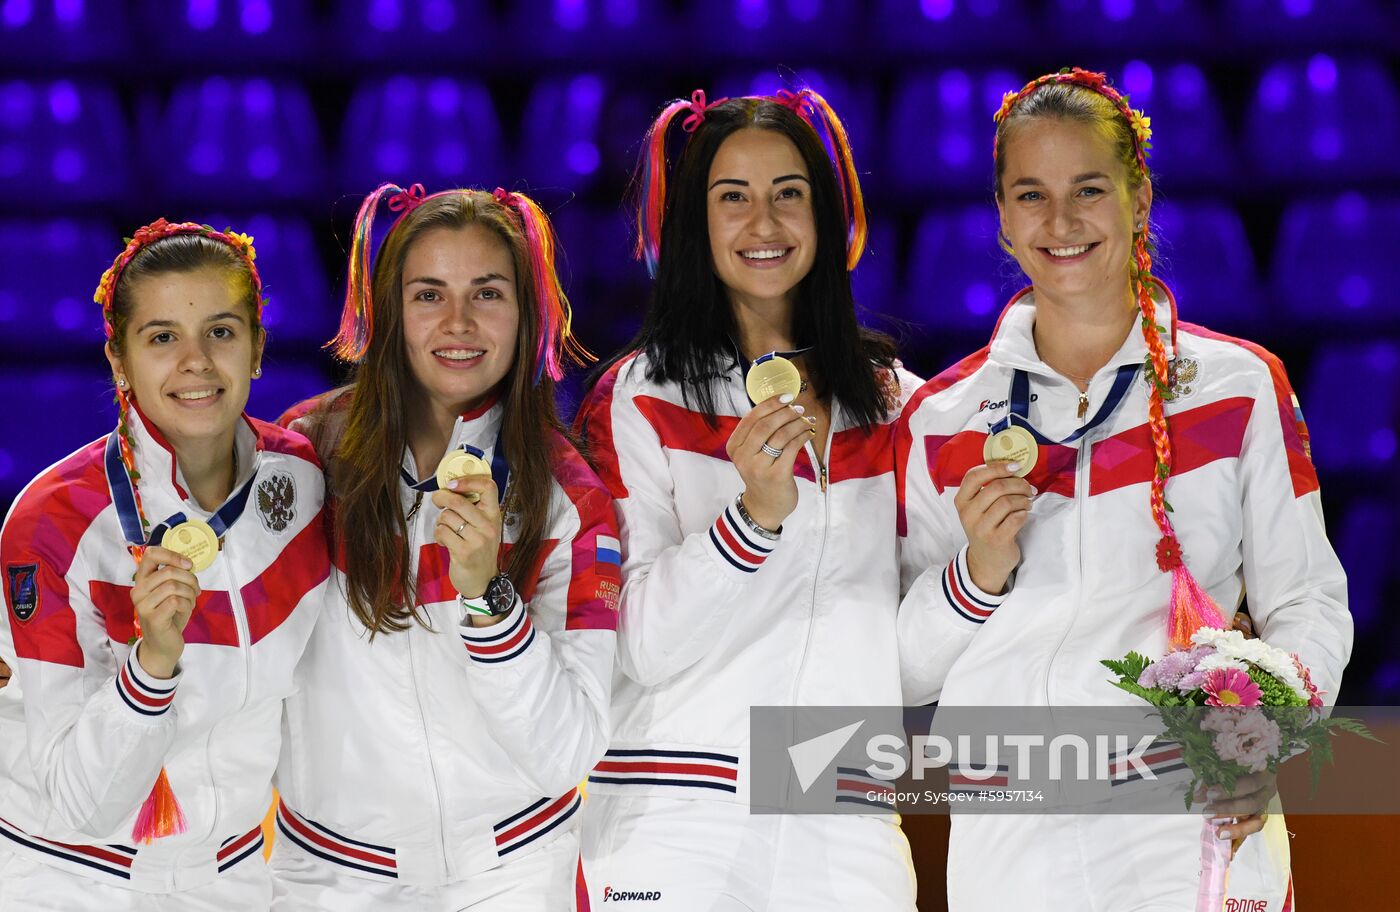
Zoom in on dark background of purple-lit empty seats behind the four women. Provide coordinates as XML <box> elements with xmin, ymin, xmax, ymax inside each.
<box><xmin>0</xmin><ymin>0</ymin><xmax>1400</xmax><ymax>908</ymax></box>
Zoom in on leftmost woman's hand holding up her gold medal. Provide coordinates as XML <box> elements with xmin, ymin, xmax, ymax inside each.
<box><xmin>132</xmin><ymin>546</ymin><xmax>203</xmax><ymax>679</ymax></box>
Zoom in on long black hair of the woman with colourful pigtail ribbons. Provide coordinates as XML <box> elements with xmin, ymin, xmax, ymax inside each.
<box><xmin>591</xmin><ymin>97</ymin><xmax>895</xmax><ymax>427</ymax></box>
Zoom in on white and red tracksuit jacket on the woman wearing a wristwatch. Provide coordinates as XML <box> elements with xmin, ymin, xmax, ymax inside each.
<box><xmin>273</xmin><ymin>394</ymin><xmax>620</xmax><ymax>887</ymax></box>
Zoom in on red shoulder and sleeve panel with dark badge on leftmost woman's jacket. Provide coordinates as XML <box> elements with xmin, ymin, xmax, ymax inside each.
<box><xmin>0</xmin><ymin>437</ymin><xmax>112</xmax><ymax>668</ymax></box>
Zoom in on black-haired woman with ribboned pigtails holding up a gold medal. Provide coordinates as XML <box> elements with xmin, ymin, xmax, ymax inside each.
<box><xmin>578</xmin><ymin>90</ymin><xmax>917</xmax><ymax>911</ymax></box>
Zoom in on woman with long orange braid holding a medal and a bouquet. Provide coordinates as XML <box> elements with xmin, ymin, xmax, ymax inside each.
<box><xmin>899</xmin><ymin>70</ymin><xmax>1352</xmax><ymax>912</ymax></box>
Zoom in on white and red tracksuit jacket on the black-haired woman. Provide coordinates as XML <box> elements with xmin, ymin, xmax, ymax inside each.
<box><xmin>578</xmin><ymin>353</ymin><xmax>918</xmax><ymax>803</ymax></box>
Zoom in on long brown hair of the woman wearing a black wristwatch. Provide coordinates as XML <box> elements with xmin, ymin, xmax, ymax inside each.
<box><xmin>312</xmin><ymin>191</ymin><xmax>564</xmax><ymax>636</ymax></box>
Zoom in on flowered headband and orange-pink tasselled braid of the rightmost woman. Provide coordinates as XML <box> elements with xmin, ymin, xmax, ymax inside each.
<box><xmin>993</xmin><ymin>67</ymin><xmax>1228</xmax><ymax>649</ymax></box>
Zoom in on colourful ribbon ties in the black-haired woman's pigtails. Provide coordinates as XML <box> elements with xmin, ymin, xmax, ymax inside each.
<box><xmin>633</xmin><ymin>88</ymin><xmax>867</xmax><ymax>277</ymax></box>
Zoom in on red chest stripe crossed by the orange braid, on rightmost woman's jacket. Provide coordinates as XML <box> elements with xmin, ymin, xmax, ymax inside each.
<box><xmin>1089</xmin><ymin>396</ymin><xmax>1254</xmax><ymax>497</ymax></box>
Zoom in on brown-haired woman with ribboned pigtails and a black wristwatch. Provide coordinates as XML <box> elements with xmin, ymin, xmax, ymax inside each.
<box><xmin>272</xmin><ymin>184</ymin><xmax>620</xmax><ymax>912</ymax></box>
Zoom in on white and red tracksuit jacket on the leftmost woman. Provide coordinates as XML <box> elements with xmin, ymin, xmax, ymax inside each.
<box><xmin>0</xmin><ymin>409</ymin><xmax>330</xmax><ymax>892</ymax></box>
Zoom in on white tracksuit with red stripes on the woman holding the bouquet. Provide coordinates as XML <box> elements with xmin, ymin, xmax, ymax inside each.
<box><xmin>897</xmin><ymin>291</ymin><xmax>1352</xmax><ymax>912</ymax></box>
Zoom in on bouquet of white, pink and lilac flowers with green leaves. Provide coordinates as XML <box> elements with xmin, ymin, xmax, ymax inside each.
<box><xmin>1103</xmin><ymin>628</ymin><xmax>1376</xmax><ymax>912</ymax></box>
